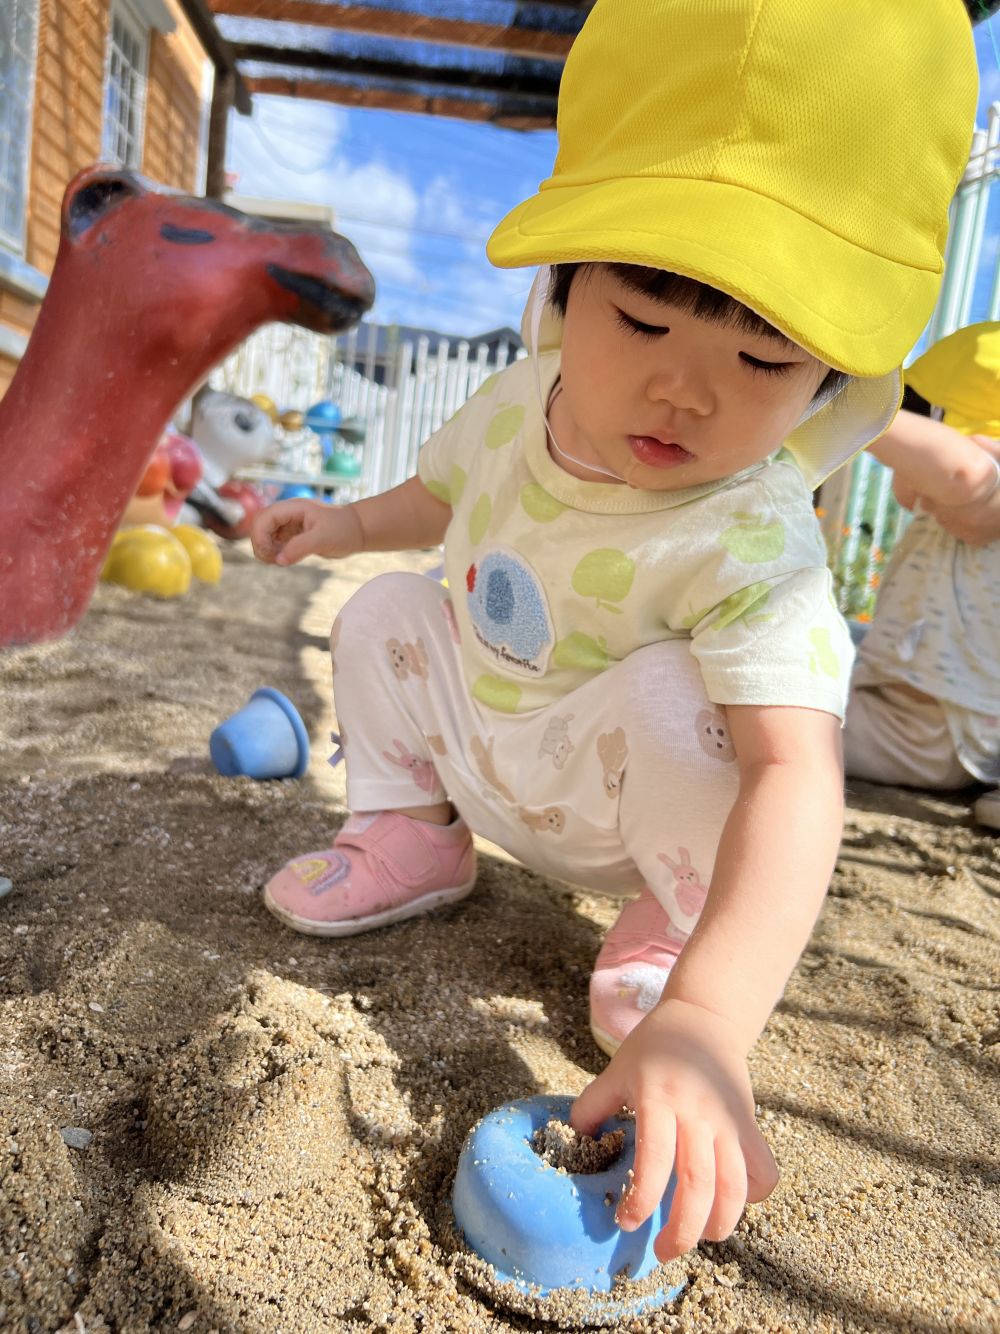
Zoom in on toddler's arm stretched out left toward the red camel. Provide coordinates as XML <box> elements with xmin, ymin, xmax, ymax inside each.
<box><xmin>251</xmin><ymin>478</ymin><xmax>452</xmax><ymax>566</ymax></box>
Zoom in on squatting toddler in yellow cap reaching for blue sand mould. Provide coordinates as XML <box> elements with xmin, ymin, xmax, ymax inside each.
<box><xmin>252</xmin><ymin>0</ymin><xmax>976</xmax><ymax>1259</ymax></box>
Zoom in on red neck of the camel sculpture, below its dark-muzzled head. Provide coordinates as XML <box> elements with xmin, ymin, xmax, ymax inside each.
<box><xmin>0</xmin><ymin>258</ymin><xmax>265</xmax><ymax>647</ymax></box>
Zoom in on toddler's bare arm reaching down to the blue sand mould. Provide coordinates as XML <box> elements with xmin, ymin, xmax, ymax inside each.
<box><xmin>572</xmin><ymin>706</ymin><xmax>843</xmax><ymax>1261</ymax></box>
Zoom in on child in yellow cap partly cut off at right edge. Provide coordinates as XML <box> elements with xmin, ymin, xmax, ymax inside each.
<box><xmin>844</xmin><ymin>321</ymin><xmax>1000</xmax><ymax>828</ymax></box>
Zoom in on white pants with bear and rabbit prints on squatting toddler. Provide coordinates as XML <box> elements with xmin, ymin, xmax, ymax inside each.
<box><xmin>331</xmin><ymin>574</ymin><xmax>737</xmax><ymax>939</ymax></box>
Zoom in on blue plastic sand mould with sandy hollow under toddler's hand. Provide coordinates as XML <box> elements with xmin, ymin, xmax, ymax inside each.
<box><xmin>452</xmin><ymin>1095</ymin><xmax>683</xmax><ymax>1318</ymax></box>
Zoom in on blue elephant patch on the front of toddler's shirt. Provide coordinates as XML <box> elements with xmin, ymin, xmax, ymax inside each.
<box><xmin>465</xmin><ymin>547</ymin><xmax>555</xmax><ymax>676</ymax></box>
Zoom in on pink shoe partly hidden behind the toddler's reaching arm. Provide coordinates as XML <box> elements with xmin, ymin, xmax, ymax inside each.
<box><xmin>591</xmin><ymin>886</ymin><xmax>688</xmax><ymax>1057</ymax></box>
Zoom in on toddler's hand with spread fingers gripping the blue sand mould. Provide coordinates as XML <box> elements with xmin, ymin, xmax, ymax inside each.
<box><xmin>571</xmin><ymin>999</ymin><xmax>777</xmax><ymax>1262</ymax></box>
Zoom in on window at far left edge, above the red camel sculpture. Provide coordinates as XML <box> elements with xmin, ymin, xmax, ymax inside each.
<box><xmin>0</xmin><ymin>0</ymin><xmax>39</xmax><ymax>255</ymax></box>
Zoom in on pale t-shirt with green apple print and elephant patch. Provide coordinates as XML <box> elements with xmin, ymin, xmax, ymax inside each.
<box><xmin>417</xmin><ymin>354</ymin><xmax>853</xmax><ymax>718</ymax></box>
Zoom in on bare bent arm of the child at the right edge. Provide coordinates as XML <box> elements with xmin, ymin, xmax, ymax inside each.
<box><xmin>868</xmin><ymin>408</ymin><xmax>1000</xmax><ymax>520</ymax></box>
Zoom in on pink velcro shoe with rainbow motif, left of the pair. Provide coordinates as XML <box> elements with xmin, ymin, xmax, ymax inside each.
<box><xmin>264</xmin><ymin>811</ymin><xmax>476</xmax><ymax>935</ymax></box>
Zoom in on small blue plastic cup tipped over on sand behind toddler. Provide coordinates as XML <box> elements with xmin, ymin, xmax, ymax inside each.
<box><xmin>208</xmin><ymin>686</ymin><xmax>309</xmax><ymax>779</ymax></box>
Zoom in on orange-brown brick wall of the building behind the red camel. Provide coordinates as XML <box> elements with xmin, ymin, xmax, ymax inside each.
<box><xmin>0</xmin><ymin>0</ymin><xmax>204</xmax><ymax>394</ymax></box>
